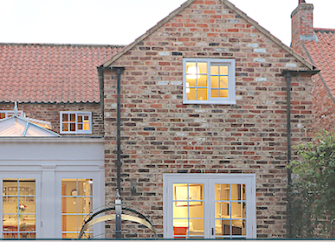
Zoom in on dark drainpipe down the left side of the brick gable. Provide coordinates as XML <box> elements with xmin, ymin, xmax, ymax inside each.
<box><xmin>112</xmin><ymin>67</ymin><xmax>125</xmax><ymax>195</ymax></box>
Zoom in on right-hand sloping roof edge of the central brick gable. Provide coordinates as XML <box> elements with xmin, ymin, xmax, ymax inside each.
<box><xmin>221</xmin><ymin>0</ymin><xmax>316</xmax><ymax>70</ymax></box>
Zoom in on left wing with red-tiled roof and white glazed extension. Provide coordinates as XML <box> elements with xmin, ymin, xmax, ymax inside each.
<box><xmin>0</xmin><ymin>44</ymin><xmax>120</xmax><ymax>238</ymax></box>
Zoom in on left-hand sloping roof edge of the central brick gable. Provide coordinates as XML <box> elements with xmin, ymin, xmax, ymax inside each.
<box><xmin>103</xmin><ymin>0</ymin><xmax>196</xmax><ymax>67</ymax></box>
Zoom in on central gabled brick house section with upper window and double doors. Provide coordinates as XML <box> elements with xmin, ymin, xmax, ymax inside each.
<box><xmin>100</xmin><ymin>0</ymin><xmax>317</xmax><ymax>238</ymax></box>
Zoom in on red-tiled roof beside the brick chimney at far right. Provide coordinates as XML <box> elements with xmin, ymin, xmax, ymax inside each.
<box><xmin>302</xmin><ymin>28</ymin><xmax>335</xmax><ymax>97</ymax></box>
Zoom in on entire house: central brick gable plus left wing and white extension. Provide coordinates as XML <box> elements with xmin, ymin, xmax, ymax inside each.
<box><xmin>0</xmin><ymin>0</ymin><xmax>322</xmax><ymax>239</ymax></box>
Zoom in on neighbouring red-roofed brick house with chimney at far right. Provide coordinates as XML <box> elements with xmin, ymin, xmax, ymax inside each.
<box><xmin>291</xmin><ymin>1</ymin><xmax>335</xmax><ymax>132</ymax></box>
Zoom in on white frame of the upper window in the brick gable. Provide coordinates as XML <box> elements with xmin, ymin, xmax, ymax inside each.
<box><xmin>183</xmin><ymin>58</ymin><xmax>236</xmax><ymax>104</ymax></box>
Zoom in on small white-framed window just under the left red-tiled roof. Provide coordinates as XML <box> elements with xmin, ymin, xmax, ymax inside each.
<box><xmin>60</xmin><ymin>111</ymin><xmax>92</xmax><ymax>134</ymax></box>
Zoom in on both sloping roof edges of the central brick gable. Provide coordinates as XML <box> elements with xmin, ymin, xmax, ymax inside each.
<box><xmin>104</xmin><ymin>0</ymin><xmax>315</xmax><ymax>70</ymax></box>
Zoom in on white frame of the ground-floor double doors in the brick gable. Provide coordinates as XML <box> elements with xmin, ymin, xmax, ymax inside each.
<box><xmin>163</xmin><ymin>174</ymin><xmax>256</xmax><ymax>239</ymax></box>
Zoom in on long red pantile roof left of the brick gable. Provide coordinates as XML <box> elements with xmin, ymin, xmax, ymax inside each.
<box><xmin>0</xmin><ymin>43</ymin><xmax>122</xmax><ymax>103</ymax></box>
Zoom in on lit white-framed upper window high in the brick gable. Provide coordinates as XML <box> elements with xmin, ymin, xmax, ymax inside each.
<box><xmin>183</xmin><ymin>58</ymin><xmax>236</xmax><ymax>104</ymax></box>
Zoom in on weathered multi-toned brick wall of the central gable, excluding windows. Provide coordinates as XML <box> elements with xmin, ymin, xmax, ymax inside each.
<box><xmin>104</xmin><ymin>0</ymin><xmax>312</xmax><ymax>238</ymax></box>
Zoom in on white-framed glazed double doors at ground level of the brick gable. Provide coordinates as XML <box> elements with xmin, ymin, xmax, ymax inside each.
<box><xmin>163</xmin><ymin>174</ymin><xmax>256</xmax><ymax>239</ymax></box>
